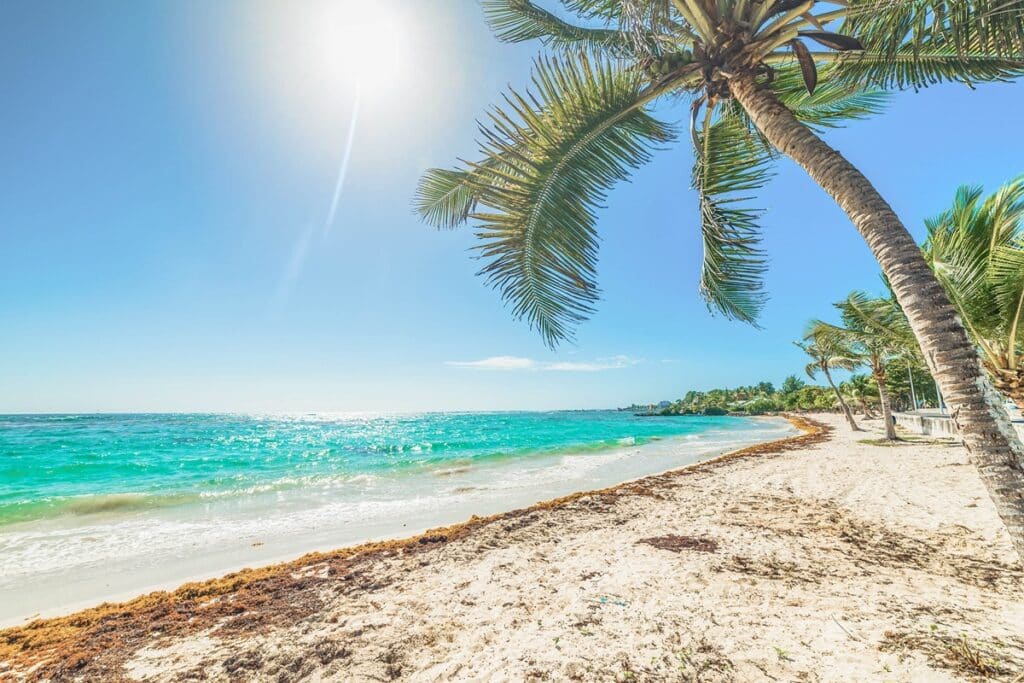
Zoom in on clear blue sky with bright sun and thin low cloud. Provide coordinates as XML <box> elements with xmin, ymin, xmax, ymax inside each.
<box><xmin>0</xmin><ymin>0</ymin><xmax>1024</xmax><ymax>413</ymax></box>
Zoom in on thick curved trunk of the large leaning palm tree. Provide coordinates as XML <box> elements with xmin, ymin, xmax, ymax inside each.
<box><xmin>729</xmin><ymin>75</ymin><xmax>1024</xmax><ymax>561</ymax></box>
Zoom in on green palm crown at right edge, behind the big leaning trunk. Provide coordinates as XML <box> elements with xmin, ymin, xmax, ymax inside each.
<box><xmin>924</xmin><ymin>178</ymin><xmax>1024</xmax><ymax>409</ymax></box>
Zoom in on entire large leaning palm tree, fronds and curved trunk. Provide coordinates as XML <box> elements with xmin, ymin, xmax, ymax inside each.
<box><xmin>416</xmin><ymin>0</ymin><xmax>1024</xmax><ymax>557</ymax></box>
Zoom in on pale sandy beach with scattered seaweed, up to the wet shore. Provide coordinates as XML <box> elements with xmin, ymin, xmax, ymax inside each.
<box><xmin>0</xmin><ymin>416</ymin><xmax>1024</xmax><ymax>681</ymax></box>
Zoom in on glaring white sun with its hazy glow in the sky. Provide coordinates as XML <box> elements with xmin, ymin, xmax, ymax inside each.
<box><xmin>226</xmin><ymin>0</ymin><xmax>454</xmax><ymax>162</ymax></box>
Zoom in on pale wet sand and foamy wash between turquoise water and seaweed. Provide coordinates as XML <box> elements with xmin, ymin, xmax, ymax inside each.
<box><xmin>0</xmin><ymin>419</ymin><xmax>795</xmax><ymax>628</ymax></box>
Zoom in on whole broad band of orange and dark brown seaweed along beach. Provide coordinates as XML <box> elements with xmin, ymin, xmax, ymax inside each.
<box><xmin>0</xmin><ymin>416</ymin><xmax>830</xmax><ymax>681</ymax></box>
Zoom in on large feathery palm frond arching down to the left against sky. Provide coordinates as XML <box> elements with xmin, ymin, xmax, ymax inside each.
<box><xmin>446</xmin><ymin>55</ymin><xmax>674</xmax><ymax>346</ymax></box>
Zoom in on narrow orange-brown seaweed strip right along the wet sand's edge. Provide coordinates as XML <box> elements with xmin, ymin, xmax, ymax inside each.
<box><xmin>0</xmin><ymin>415</ymin><xmax>830</xmax><ymax>674</ymax></box>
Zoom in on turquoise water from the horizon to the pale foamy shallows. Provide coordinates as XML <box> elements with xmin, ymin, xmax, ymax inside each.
<box><xmin>0</xmin><ymin>412</ymin><xmax>770</xmax><ymax>525</ymax></box>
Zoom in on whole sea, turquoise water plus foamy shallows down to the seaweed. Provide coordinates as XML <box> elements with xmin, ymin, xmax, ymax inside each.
<box><xmin>0</xmin><ymin>411</ymin><xmax>795</xmax><ymax>623</ymax></box>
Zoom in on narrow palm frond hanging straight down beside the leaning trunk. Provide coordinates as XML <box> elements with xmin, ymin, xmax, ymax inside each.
<box><xmin>692</xmin><ymin>107</ymin><xmax>771</xmax><ymax>325</ymax></box>
